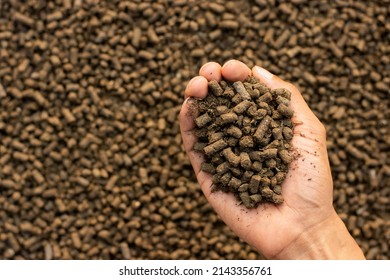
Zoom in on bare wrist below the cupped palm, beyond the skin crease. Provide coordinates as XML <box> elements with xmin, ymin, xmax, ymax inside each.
<box><xmin>275</xmin><ymin>210</ymin><xmax>365</xmax><ymax>260</ymax></box>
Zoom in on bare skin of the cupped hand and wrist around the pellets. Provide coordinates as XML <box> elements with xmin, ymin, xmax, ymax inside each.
<box><xmin>179</xmin><ymin>60</ymin><xmax>364</xmax><ymax>259</ymax></box>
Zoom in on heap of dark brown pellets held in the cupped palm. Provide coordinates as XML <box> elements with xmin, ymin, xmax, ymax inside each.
<box><xmin>193</xmin><ymin>76</ymin><xmax>293</xmax><ymax>208</ymax></box>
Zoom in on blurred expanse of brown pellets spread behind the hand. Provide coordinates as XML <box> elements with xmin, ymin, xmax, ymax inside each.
<box><xmin>0</xmin><ymin>0</ymin><xmax>390</xmax><ymax>259</ymax></box>
